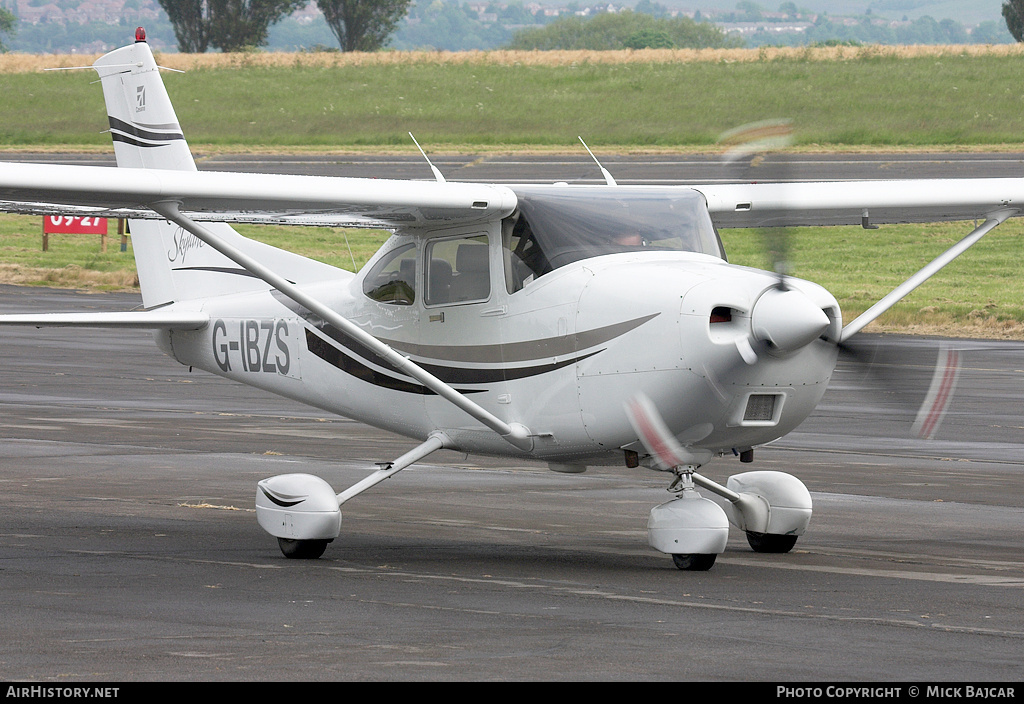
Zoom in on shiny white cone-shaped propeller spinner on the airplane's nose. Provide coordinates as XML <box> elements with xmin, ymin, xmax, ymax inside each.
<box><xmin>751</xmin><ymin>289</ymin><xmax>829</xmax><ymax>352</ymax></box>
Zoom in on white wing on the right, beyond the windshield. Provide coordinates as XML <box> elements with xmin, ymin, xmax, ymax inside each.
<box><xmin>691</xmin><ymin>178</ymin><xmax>1024</xmax><ymax>227</ymax></box>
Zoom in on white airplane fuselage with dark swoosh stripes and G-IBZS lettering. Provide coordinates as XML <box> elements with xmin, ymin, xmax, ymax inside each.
<box><xmin>155</xmin><ymin>215</ymin><xmax>841</xmax><ymax>469</ymax></box>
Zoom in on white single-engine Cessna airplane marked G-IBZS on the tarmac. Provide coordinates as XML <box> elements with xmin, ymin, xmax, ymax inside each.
<box><xmin>0</xmin><ymin>31</ymin><xmax>1024</xmax><ymax>570</ymax></box>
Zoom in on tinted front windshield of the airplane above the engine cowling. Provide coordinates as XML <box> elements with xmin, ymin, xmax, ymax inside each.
<box><xmin>505</xmin><ymin>186</ymin><xmax>724</xmax><ymax>293</ymax></box>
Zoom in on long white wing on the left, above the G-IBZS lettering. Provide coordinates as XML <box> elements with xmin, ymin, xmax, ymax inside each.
<box><xmin>0</xmin><ymin>163</ymin><xmax>516</xmax><ymax>229</ymax></box>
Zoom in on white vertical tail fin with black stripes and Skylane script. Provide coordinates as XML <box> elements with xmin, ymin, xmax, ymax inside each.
<box><xmin>92</xmin><ymin>33</ymin><xmax>343</xmax><ymax>307</ymax></box>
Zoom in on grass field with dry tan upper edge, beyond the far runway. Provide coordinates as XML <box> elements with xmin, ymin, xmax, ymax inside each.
<box><xmin>6</xmin><ymin>51</ymin><xmax>1024</xmax><ymax>151</ymax></box>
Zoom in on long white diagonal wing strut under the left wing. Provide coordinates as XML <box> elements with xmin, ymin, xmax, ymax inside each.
<box><xmin>150</xmin><ymin>201</ymin><xmax>534</xmax><ymax>450</ymax></box>
